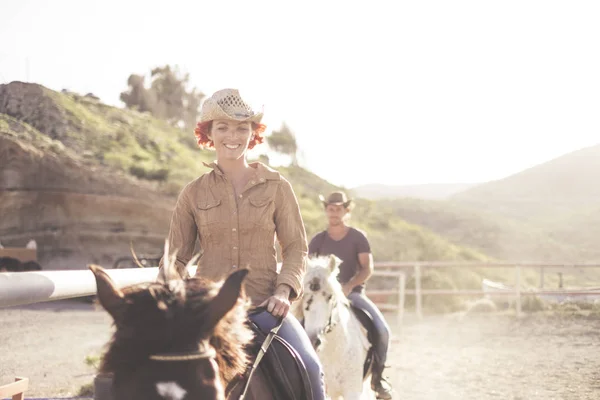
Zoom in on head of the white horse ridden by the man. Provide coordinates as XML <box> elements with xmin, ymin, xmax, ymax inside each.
<box><xmin>297</xmin><ymin>254</ymin><xmax>348</xmax><ymax>350</ymax></box>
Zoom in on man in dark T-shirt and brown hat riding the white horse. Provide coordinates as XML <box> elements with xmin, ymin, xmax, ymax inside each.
<box><xmin>308</xmin><ymin>192</ymin><xmax>392</xmax><ymax>399</ymax></box>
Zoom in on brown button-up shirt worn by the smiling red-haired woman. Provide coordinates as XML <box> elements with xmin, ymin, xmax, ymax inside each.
<box><xmin>159</xmin><ymin>163</ymin><xmax>308</xmax><ymax>305</ymax></box>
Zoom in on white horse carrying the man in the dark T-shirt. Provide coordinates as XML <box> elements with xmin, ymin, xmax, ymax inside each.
<box><xmin>292</xmin><ymin>255</ymin><xmax>375</xmax><ymax>400</ymax></box>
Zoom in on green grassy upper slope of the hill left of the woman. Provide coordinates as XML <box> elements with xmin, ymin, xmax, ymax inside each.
<box><xmin>0</xmin><ymin>83</ymin><xmax>212</xmax><ymax>194</ymax></box>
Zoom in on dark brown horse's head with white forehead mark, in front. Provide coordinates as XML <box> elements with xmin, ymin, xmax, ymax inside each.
<box><xmin>89</xmin><ymin>241</ymin><xmax>252</xmax><ymax>399</ymax></box>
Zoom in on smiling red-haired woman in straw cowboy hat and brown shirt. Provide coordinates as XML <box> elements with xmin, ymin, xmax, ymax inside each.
<box><xmin>160</xmin><ymin>89</ymin><xmax>325</xmax><ymax>400</ymax></box>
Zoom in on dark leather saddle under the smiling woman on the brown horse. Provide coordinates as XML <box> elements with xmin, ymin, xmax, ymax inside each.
<box><xmin>227</xmin><ymin>310</ymin><xmax>312</xmax><ymax>400</ymax></box>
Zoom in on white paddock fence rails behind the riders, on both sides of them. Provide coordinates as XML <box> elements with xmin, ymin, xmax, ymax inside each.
<box><xmin>0</xmin><ymin>261</ymin><xmax>600</xmax><ymax>321</ymax></box>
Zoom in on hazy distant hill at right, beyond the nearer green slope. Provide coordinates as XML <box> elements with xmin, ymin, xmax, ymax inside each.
<box><xmin>370</xmin><ymin>145</ymin><xmax>600</xmax><ymax>263</ymax></box>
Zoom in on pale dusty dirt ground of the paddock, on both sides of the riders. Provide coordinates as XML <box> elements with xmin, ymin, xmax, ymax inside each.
<box><xmin>0</xmin><ymin>300</ymin><xmax>600</xmax><ymax>400</ymax></box>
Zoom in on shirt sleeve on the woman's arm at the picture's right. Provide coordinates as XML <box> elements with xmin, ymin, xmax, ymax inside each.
<box><xmin>275</xmin><ymin>179</ymin><xmax>308</xmax><ymax>301</ymax></box>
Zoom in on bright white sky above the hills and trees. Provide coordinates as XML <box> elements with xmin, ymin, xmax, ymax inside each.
<box><xmin>0</xmin><ymin>0</ymin><xmax>600</xmax><ymax>187</ymax></box>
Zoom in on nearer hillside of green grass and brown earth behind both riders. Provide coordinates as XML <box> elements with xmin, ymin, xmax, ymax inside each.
<box><xmin>0</xmin><ymin>82</ymin><xmax>486</xmax><ymax>269</ymax></box>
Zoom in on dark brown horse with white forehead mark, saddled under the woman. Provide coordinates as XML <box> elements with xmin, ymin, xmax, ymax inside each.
<box><xmin>89</xmin><ymin>245</ymin><xmax>310</xmax><ymax>400</ymax></box>
